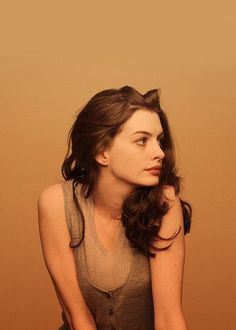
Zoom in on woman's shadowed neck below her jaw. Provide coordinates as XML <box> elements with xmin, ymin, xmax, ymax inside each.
<box><xmin>92</xmin><ymin>173</ymin><xmax>134</xmax><ymax>220</ymax></box>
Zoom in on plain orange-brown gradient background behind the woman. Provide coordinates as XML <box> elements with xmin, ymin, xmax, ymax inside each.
<box><xmin>0</xmin><ymin>0</ymin><xmax>236</xmax><ymax>330</ymax></box>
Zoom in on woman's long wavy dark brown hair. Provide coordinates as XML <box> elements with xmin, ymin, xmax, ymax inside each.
<box><xmin>61</xmin><ymin>86</ymin><xmax>192</xmax><ymax>257</ymax></box>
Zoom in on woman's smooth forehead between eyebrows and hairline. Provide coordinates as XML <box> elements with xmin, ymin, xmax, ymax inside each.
<box><xmin>122</xmin><ymin>109</ymin><xmax>162</xmax><ymax>134</ymax></box>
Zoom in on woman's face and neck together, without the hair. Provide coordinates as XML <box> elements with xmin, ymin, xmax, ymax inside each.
<box><xmin>92</xmin><ymin>109</ymin><xmax>165</xmax><ymax>219</ymax></box>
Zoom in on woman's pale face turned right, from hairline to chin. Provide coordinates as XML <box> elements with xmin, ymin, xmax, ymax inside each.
<box><xmin>100</xmin><ymin>109</ymin><xmax>164</xmax><ymax>187</ymax></box>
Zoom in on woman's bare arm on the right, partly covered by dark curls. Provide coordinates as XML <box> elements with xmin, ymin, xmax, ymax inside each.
<box><xmin>150</xmin><ymin>187</ymin><xmax>185</xmax><ymax>329</ymax></box>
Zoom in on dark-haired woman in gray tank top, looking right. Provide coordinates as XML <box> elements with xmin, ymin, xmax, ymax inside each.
<box><xmin>38</xmin><ymin>86</ymin><xmax>191</xmax><ymax>330</ymax></box>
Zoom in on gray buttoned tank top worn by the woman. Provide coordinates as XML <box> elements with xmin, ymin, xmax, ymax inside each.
<box><xmin>60</xmin><ymin>180</ymin><xmax>154</xmax><ymax>330</ymax></box>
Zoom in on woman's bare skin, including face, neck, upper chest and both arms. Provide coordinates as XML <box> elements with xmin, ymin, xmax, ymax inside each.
<box><xmin>38</xmin><ymin>109</ymin><xmax>187</xmax><ymax>330</ymax></box>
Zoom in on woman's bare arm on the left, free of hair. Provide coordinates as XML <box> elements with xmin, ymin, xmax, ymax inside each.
<box><xmin>38</xmin><ymin>184</ymin><xmax>94</xmax><ymax>328</ymax></box>
